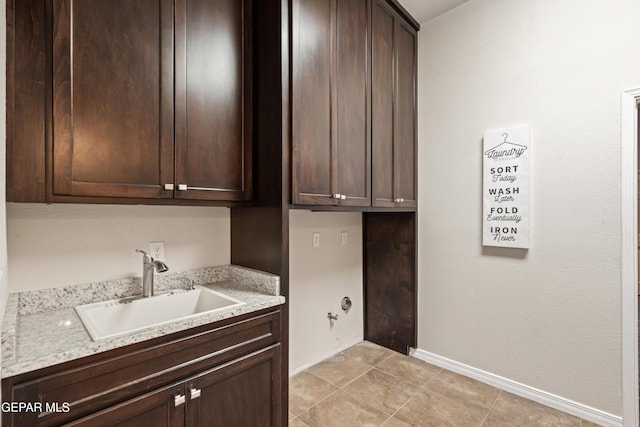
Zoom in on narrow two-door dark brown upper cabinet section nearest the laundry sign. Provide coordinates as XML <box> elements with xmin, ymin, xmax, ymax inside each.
<box><xmin>371</xmin><ymin>0</ymin><xmax>417</xmax><ymax>208</ymax></box>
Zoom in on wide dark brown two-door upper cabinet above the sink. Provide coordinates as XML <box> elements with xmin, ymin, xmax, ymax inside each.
<box><xmin>8</xmin><ymin>0</ymin><xmax>252</xmax><ymax>203</ymax></box>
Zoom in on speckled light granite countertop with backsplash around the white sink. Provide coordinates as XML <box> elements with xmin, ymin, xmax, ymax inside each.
<box><xmin>2</xmin><ymin>265</ymin><xmax>285</xmax><ymax>378</ymax></box>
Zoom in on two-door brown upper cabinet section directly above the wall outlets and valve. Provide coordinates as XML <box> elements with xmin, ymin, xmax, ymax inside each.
<box><xmin>291</xmin><ymin>0</ymin><xmax>371</xmax><ymax>206</ymax></box>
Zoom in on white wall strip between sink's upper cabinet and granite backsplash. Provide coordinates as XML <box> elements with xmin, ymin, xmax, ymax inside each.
<box><xmin>7</xmin><ymin>203</ymin><xmax>231</xmax><ymax>292</ymax></box>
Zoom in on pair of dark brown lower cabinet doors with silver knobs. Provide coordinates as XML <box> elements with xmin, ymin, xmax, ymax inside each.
<box><xmin>67</xmin><ymin>344</ymin><xmax>281</xmax><ymax>427</ymax></box>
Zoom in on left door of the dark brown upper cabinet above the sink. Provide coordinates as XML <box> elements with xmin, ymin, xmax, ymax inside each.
<box><xmin>52</xmin><ymin>0</ymin><xmax>174</xmax><ymax>198</ymax></box>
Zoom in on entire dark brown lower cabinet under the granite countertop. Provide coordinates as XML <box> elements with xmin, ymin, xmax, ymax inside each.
<box><xmin>2</xmin><ymin>310</ymin><xmax>286</xmax><ymax>427</ymax></box>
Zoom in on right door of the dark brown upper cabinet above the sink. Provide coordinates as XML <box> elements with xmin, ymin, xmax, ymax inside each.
<box><xmin>175</xmin><ymin>0</ymin><xmax>252</xmax><ymax>201</ymax></box>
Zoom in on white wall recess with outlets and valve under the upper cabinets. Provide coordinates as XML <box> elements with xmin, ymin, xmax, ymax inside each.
<box><xmin>289</xmin><ymin>210</ymin><xmax>363</xmax><ymax>374</ymax></box>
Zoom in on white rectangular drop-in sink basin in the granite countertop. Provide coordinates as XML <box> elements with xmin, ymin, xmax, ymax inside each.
<box><xmin>75</xmin><ymin>286</ymin><xmax>244</xmax><ymax>341</ymax></box>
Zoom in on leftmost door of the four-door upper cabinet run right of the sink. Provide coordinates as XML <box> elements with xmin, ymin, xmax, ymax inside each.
<box><xmin>291</xmin><ymin>0</ymin><xmax>337</xmax><ymax>205</ymax></box>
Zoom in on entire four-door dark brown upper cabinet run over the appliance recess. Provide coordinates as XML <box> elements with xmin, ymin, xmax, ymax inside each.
<box><xmin>291</xmin><ymin>0</ymin><xmax>419</xmax><ymax>210</ymax></box>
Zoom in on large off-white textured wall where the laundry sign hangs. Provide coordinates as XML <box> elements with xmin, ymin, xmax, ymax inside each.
<box><xmin>418</xmin><ymin>0</ymin><xmax>640</xmax><ymax>415</ymax></box>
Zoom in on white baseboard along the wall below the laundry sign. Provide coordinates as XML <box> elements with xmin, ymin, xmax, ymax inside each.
<box><xmin>413</xmin><ymin>349</ymin><xmax>623</xmax><ymax>427</ymax></box>
